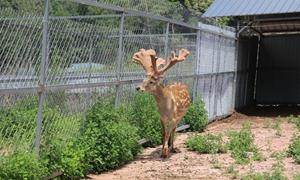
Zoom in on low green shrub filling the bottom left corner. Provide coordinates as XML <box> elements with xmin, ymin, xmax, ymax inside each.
<box><xmin>0</xmin><ymin>152</ymin><xmax>48</xmax><ymax>180</ymax></box>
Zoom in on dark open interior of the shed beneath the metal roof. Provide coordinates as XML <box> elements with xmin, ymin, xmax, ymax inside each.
<box><xmin>236</xmin><ymin>16</ymin><xmax>300</xmax><ymax>108</ymax></box>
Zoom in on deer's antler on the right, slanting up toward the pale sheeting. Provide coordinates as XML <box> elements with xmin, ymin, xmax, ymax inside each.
<box><xmin>158</xmin><ymin>49</ymin><xmax>190</xmax><ymax>74</ymax></box>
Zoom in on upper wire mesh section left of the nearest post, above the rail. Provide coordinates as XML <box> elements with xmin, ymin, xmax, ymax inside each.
<box><xmin>0</xmin><ymin>16</ymin><xmax>42</xmax><ymax>89</ymax></box>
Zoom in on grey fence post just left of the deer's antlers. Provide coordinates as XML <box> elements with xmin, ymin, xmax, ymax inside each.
<box><xmin>115</xmin><ymin>12</ymin><xmax>125</xmax><ymax>106</ymax></box>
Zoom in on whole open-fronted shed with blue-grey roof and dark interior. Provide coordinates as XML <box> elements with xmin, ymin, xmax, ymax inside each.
<box><xmin>203</xmin><ymin>0</ymin><xmax>300</xmax><ymax>108</ymax></box>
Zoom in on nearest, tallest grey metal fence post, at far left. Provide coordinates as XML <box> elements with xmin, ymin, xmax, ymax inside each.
<box><xmin>34</xmin><ymin>0</ymin><xmax>49</xmax><ymax>157</ymax></box>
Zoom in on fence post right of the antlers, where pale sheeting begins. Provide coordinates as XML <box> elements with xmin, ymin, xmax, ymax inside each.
<box><xmin>193</xmin><ymin>29</ymin><xmax>201</xmax><ymax>101</ymax></box>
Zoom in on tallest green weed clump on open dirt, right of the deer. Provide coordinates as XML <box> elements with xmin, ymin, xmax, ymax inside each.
<box><xmin>227</xmin><ymin>123</ymin><xmax>258</xmax><ymax>164</ymax></box>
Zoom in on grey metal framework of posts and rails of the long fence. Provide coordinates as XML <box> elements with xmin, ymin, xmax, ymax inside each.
<box><xmin>0</xmin><ymin>0</ymin><xmax>237</xmax><ymax>155</ymax></box>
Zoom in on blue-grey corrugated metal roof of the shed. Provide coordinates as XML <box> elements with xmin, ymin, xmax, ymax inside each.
<box><xmin>202</xmin><ymin>0</ymin><xmax>300</xmax><ymax>17</ymax></box>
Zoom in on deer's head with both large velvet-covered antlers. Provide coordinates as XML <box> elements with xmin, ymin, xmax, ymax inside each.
<box><xmin>132</xmin><ymin>49</ymin><xmax>189</xmax><ymax>93</ymax></box>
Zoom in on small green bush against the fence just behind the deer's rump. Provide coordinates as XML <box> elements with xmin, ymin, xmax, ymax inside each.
<box><xmin>183</xmin><ymin>98</ymin><xmax>208</xmax><ymax>132</ymax></box>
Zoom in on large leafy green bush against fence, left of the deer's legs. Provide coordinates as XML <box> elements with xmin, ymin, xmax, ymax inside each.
<box><xmin>82</xmin><ymin>101</ymin><xmax>140</xmax><ymax>172</ymax></box>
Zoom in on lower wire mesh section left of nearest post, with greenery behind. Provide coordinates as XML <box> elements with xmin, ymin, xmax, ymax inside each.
<box><xmin>0</xmin><ymin>93</ymin><xmax>38</xmax><ymax>155</ymax></box>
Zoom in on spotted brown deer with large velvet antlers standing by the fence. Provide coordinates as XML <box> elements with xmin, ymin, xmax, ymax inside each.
<box><xmin>132</xmin><ymin>49</ymin><xmax>191</xmax><ymax>158</ymax></box>
